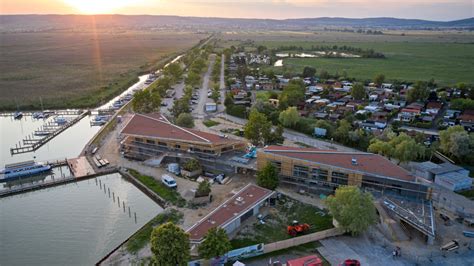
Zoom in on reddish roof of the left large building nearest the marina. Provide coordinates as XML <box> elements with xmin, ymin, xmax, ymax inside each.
<box><xmin>121</xmin><ymin>114</ymin><xmax>236</xmax><ymax>144</ymax></box>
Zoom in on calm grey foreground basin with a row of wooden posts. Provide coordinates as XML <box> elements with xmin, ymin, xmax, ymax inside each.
<box><xmin>0</xmin><ymin>174</ymin><xmax>162</xmax><ymax>265</ymax></box>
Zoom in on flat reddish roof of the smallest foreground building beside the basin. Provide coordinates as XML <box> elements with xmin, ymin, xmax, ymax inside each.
<box><xmin>186</xmin><ymin>184</ymin><xmax>274</xmax><ymax>242</ymax></box>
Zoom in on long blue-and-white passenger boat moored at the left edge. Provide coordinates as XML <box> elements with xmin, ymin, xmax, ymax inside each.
<box><xmin>0</xmin><ymin>161</ymin><xmax>52</xmax><ymax>182</ymax></box>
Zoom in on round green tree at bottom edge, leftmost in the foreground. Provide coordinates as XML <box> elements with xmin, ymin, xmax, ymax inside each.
<box><xmin>150</xmin><ymin>222</ymin><xmax>191</xmax><ymax>266</ymax></box>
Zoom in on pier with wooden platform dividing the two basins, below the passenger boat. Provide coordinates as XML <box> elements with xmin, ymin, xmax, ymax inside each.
<box><xmin>0</xmin><ymin>156</ymin><xmax>117</xmax><ymax>198</ymax></box>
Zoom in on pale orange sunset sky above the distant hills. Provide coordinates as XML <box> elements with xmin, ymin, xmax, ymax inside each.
<box><xmin>0</xmin><ymin>0</ymin><xmax>474</xmax><ymax>20</ymax></box>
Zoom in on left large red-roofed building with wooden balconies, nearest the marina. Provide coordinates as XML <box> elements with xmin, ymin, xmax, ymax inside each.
<box><xmin>120</xmin><ymin>113</ymin><xmax>247</xmax><ymax>160</ymax></box>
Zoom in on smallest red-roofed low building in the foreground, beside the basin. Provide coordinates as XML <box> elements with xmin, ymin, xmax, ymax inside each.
<box><xmin>186</xmin><ymin>184</ymin><xmax>275</xmax><ymax>245</ymax></box>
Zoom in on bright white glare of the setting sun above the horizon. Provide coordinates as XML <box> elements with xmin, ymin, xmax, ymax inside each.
<box><xmin>63</xmin><ymin>0</ymin><xmax>136</xmax><ymax>14</ymax></box>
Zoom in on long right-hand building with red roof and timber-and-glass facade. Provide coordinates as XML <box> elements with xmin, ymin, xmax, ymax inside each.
<box><xmin>257</xmin><ymin>146</ymin><xmax>431</xmax><ymax>199</ymax></box>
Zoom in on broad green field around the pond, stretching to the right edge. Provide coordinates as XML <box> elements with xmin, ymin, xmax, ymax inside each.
<box><xmin>218</xmin><ymin>31</ymin><xmax>474</xmax><ymax>85</ymax></box>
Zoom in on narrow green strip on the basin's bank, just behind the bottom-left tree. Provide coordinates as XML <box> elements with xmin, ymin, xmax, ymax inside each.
<box><xmin>126</xmin><ymin>209</ymin><xmax>183</xmax><ymax>253</ymax></box>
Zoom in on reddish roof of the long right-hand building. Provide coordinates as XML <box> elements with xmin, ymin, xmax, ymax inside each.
<box><xmin>263</xmin><ymin>146</ymin><xmax>415</xmax><ymax>181</ymax></box>
